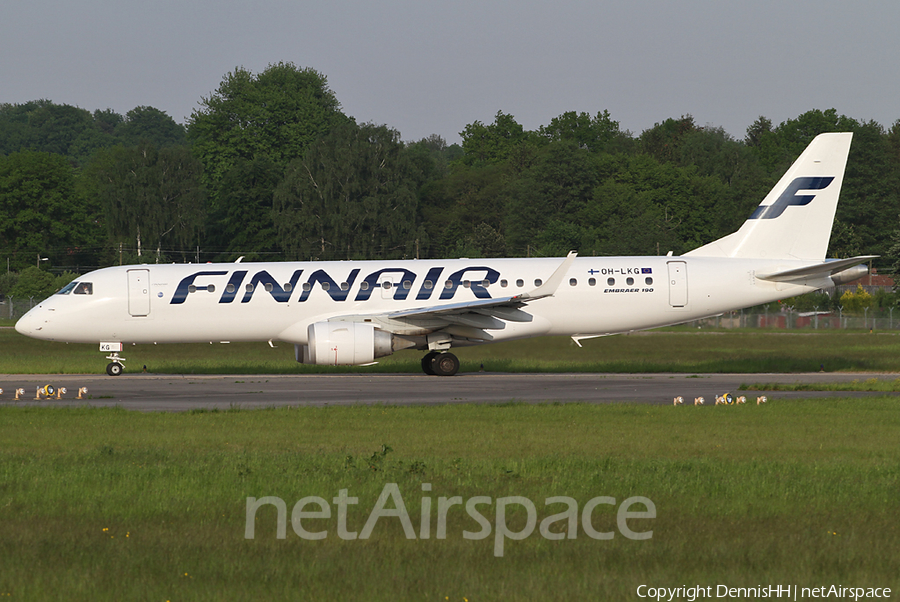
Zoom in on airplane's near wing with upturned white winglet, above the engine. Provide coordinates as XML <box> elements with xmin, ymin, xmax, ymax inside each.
<box><xmin>329</xmin><ymin>251</ymin><xmax>577</xmax><ymax>340</ymax></box>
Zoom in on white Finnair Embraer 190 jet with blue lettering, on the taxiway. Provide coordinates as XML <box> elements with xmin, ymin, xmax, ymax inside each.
<box><xmin>16</xmin><ymin>133</ymin><xmax>875</xmax><ymax>376</ymax></box>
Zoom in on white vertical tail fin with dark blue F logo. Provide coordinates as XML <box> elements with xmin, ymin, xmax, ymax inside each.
<box><xmin>685</xmin><ymin>133</ymin><xmax>853</xmax><ymax>260</ymax></box>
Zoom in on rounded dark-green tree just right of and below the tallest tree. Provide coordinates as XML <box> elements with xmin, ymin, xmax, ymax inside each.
<box><xmin>275</xmin><ymin>123</ymin><xmax>417</xmax><ymax>260</ymax></box>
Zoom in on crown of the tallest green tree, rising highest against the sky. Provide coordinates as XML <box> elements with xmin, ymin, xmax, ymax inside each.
<box><xmin>187</xmin><ymin>63</ymin><xmax>350</xmax><ymax>200</ymax></box>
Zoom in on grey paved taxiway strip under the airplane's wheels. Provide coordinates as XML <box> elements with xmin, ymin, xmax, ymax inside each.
<box><xmin>0</xmin><ymin>372</ymin><xmax>897</xmax><ymax>411</ymax></box>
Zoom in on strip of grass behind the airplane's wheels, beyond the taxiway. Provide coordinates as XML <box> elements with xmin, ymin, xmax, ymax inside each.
<box><xmin>0</xmin><ymin>328</ymin><xmax>900</xmax><ymax>374</ymax></box>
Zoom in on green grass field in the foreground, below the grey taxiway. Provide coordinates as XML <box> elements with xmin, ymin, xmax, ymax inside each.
<box><xmin>0</xmin><ymin>397</ymin><xmax>900</xmax><ymax>602</ymax></box>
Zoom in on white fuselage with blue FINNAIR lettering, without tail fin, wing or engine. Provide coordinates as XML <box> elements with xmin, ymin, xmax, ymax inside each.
<box><xmin>16</xmin><ymin>257</ymin><xmax>821</xmax><ymax>345</ymax></box>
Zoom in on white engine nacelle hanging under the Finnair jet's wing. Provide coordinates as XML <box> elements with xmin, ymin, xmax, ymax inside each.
<box><xmin>294</xmin><ymin>322</ymin><xmax>394</xmax><ymax>366</ymax></box>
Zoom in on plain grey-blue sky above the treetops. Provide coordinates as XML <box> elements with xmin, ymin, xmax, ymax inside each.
<box><xmin>0</xmin><ymin>0</ymin><xmax>900</xmax><ymax>143</ymax></box>
